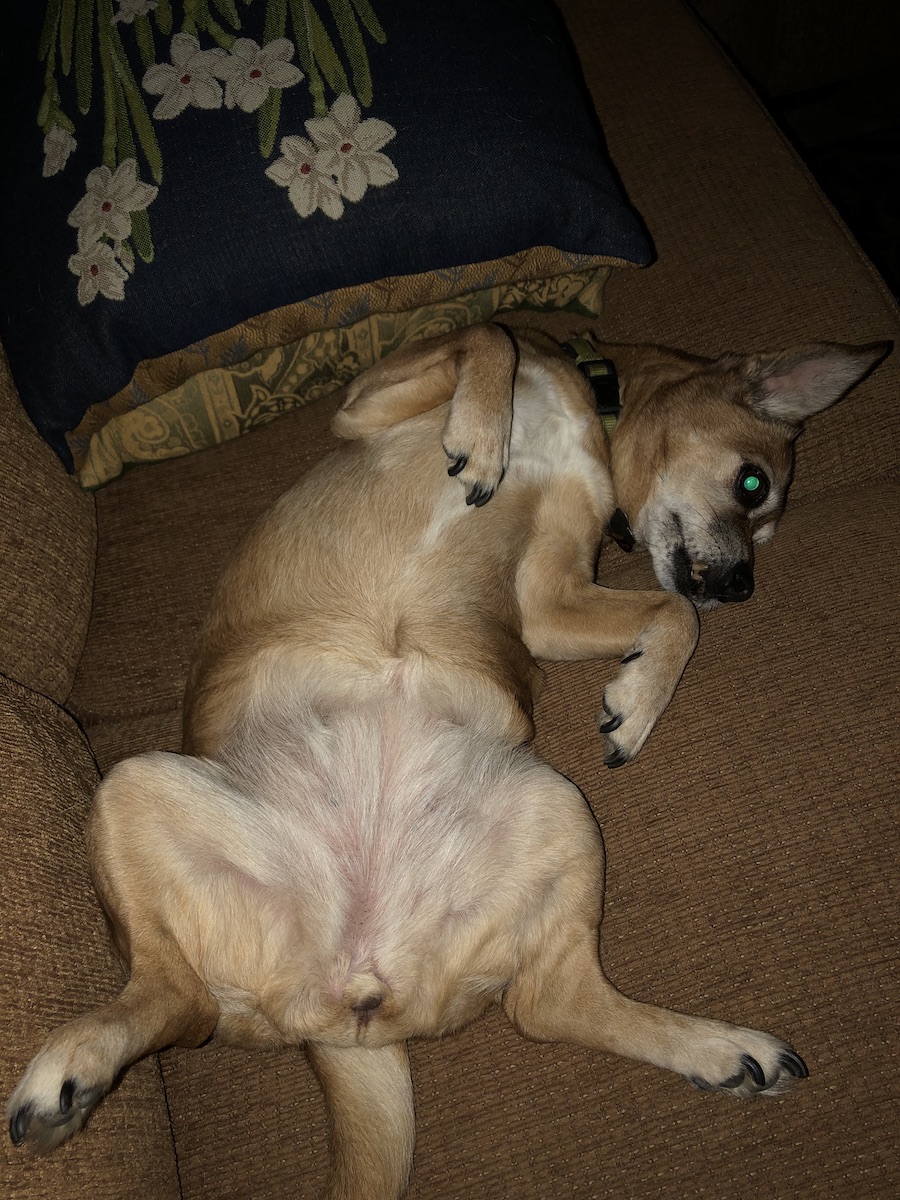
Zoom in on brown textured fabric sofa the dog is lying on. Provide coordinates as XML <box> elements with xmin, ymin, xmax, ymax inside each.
<box><xmin>0</xmin><ymin>0</ymin><xmax>900</xmax><ymax>1200</ymax></box>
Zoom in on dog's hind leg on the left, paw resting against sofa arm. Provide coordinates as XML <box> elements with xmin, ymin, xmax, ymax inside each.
<box><xmin>6</xmin><ymin>755</ymin><xmax>218</xmax><ymax>1153</ymax></box>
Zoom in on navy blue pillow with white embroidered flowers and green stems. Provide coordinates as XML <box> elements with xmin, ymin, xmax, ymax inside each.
<box><xmin>0</xmin><ymin>0</ymin><xmax>652</xmax><ymax>469</ymax></box>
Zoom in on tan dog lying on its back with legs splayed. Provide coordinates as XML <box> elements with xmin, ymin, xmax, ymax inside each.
<box><xmin>7</xmin><ymin>324</ymin><xmax>884</xmax><ymax>1200</ymax></box>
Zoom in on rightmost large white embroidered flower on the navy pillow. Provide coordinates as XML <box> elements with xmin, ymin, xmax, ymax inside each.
<box><xmin>306</xmin><ymin>95</ymin><xmax>397</xmax><ymax>200</ymax></box>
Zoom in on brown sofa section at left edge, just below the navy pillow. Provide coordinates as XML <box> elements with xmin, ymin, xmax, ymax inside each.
<box><xmin>0</xmin><ymin>352</ymin><xmax>96</xmax><ymax>701</ymax></box>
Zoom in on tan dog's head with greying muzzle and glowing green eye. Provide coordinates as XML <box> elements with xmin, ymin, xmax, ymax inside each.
<box><xmin>604</xmin><ymin>343</ymin><xmax>890</xmax><ymax>607</ymax></box>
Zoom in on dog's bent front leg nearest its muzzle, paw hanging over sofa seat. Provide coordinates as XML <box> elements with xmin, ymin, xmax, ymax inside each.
<box><xmin>517</xmin><ymin>492</ymin><xmax>700</xmax><ymax>767</ymax></box>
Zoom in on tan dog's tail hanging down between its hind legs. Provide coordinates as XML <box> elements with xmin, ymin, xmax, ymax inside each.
<box><xmin>307</xmin><ymin>1043</ymin><xmax>415</xmax><ymax>1200</ymax></box>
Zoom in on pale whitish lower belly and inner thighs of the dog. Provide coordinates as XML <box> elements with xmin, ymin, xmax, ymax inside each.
<box><xmin>168</xmin><ymin>696</ymin><xmax>590</xmax><ymax>1045</ymax></box>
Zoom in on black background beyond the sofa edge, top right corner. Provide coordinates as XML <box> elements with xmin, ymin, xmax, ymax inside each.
<box><xmin>690</xmin><ymin>0</ymin><xmax>900</xmax><ymax>296</ymax></box>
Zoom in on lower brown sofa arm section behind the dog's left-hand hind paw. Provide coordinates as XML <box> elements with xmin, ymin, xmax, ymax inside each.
<box><xmin>0</xmin><ymin>676</ymin><xmax>179</xmax><ymax>1200</ymax></box>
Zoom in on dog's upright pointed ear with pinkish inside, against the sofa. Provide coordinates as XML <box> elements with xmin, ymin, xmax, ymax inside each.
<box><xmin>724</xmin><ymin>342</ymin><xmax>893</xmax><ymax>425</ymax></box>
